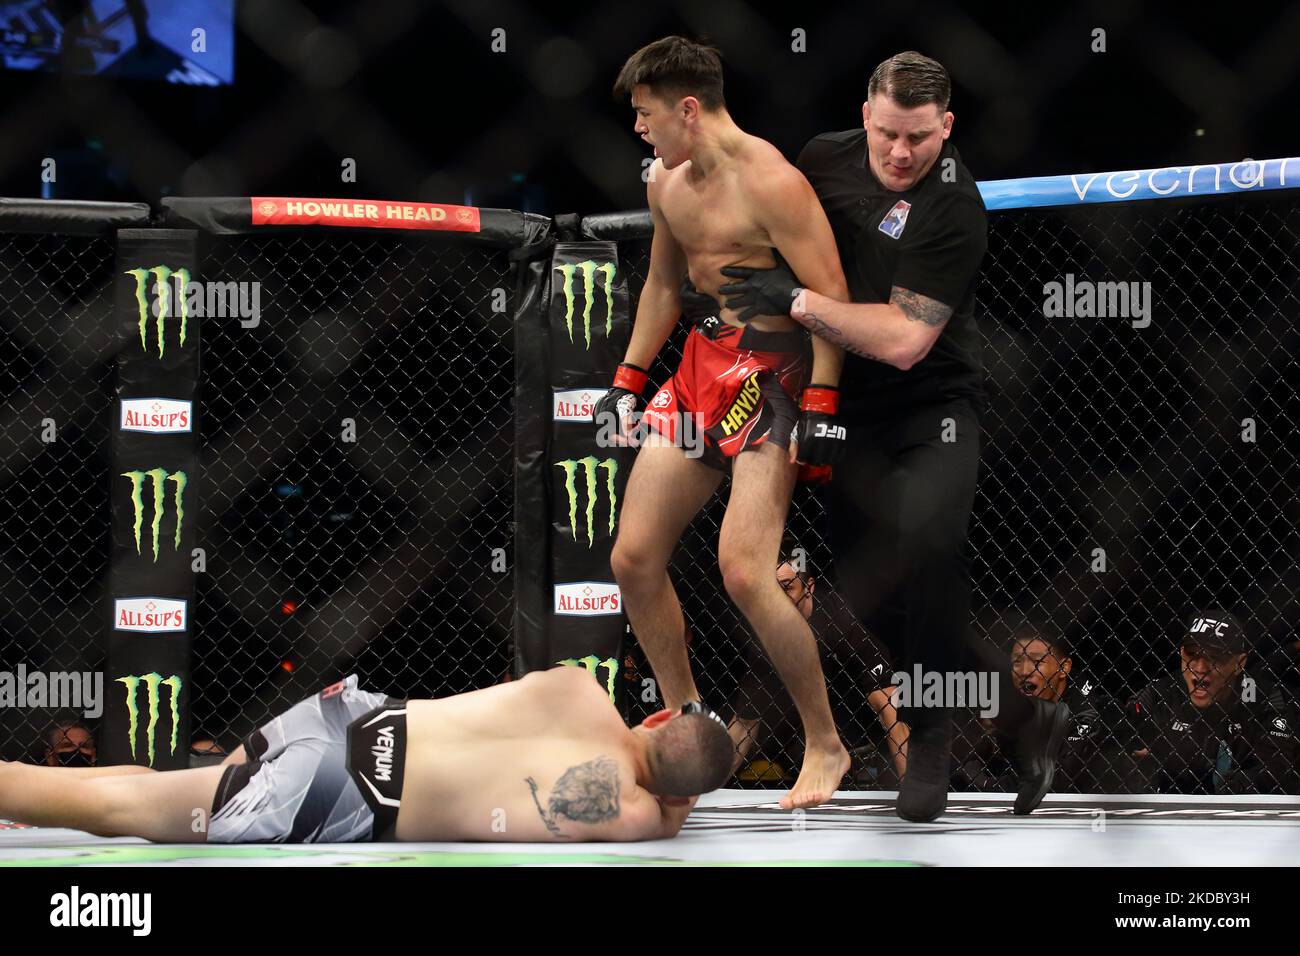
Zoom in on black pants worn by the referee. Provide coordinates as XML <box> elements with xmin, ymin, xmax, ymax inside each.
<box><xmin>823</xmin><ymin>398</ymin><xmax>1031</xmax><ymax>732</ymax></box>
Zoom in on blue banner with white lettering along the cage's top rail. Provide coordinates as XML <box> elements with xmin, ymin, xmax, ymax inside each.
<box><xmin>979</xmin><ymin>156</ymin><xmax>1300</xmax><ymax>209</ymax></box>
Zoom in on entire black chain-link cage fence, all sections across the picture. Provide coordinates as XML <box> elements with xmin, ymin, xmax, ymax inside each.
<box><xmin>0</xmin><ymin>194</ymin><xmax>1300</xmax><ymax>791</ymax></box>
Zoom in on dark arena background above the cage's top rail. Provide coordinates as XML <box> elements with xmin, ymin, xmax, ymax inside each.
<box><xmin>0</xmin><ymin>0</ymin><xmax>1300</xmax><ymax>213</ymax></box>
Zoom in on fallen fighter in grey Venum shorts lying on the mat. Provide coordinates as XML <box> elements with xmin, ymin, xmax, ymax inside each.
<box><xmin>0</xmin><ymin>667</ymin><xmax>732</xmax><ymax>843</ymax></box>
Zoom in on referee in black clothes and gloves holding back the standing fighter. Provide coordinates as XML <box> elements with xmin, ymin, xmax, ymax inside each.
<box><xmin>719</xmin><ymin>52</ymin><xmax>1069</xmax><ymax>822</ymax></box>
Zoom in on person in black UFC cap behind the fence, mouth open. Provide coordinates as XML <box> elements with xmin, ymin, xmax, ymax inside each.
<box><xmin>1126</xmin><ymin>607</ymin><xmax>1300</xmax><ymax>793</ymax></box>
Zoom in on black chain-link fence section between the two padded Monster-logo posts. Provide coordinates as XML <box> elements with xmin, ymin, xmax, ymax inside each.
<box><xmin>194</xmin><ymin>234</ymin><xmax>515</xmax><ymax>741</ymax></box>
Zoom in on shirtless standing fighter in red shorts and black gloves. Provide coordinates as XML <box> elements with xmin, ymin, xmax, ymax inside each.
<box><xmin>595</xmin><ymin>36</ymin><xmax>849</xmax><ymax>809</ymax></box>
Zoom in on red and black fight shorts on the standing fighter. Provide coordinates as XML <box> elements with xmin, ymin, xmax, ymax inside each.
<box><xmin>641</xmin><ymin>319</ymin><xmax>811</xmax><ymax>472</ymax></box>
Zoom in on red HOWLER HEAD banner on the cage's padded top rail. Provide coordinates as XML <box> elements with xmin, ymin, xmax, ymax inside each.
<box><xmin>248</xmin><ymin>196</ymin><xmax>480</xmax><ymax>233</ymax></box>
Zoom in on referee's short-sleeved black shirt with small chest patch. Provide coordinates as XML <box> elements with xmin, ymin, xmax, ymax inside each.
<box><xmin>798</xmin><ymin>129</ymin><xmax>988</xmax><ymax>419</ymax></box>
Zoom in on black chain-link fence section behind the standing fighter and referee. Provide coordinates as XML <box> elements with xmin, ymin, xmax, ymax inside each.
<box><xmin>611</xmin><ymin>191</ymin><xmax>1300</xmax><ymax>792</ymax></box>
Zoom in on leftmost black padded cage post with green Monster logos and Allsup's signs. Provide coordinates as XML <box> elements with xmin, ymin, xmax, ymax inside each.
<box><xmin>99</xmin><ymin>229</ymin><xmax>203</xmax><ymax>770</ymax></box>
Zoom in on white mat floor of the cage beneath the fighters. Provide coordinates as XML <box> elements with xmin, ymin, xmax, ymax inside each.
<box><xmin>0</xmin><ymin>790</ymin><xmax>1300</xmax><ymax>866</ymax></box>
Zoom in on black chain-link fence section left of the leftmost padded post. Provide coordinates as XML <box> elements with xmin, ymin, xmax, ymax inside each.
<box><xmin>0</xmin><ymin>233</ymin><xmax>114</xmax><ymax>760</ymax></box>
